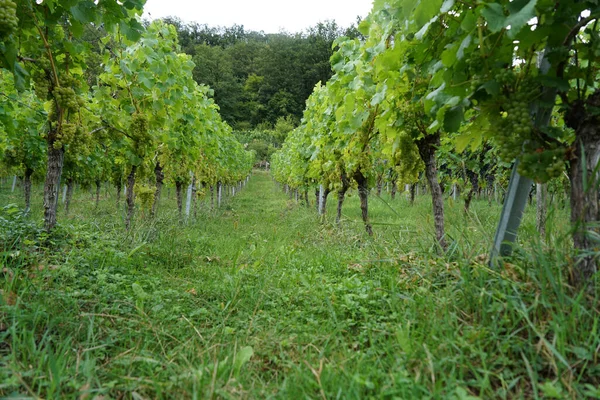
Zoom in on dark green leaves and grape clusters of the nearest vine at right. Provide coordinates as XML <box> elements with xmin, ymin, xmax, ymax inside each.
<box><xmin>372</xmin><ymin>0</ymin><xmax>597</xmax><ymax>182</ymax></box>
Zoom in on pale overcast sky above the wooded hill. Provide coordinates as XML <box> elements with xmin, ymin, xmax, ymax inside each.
<box><xmin>144</xmin><ymin>0</ymin><xmax>373</xmax><ymax>33</ymax></box>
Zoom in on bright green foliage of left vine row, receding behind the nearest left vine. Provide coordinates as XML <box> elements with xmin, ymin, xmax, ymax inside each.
<box><xmin>94</xmin><ymin>22</ymin><xmax>252</xmax><ymax>211</ymax></box>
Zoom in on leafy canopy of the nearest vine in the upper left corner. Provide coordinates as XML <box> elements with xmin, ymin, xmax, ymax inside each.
<box><xmin>0</xmin><ymin>0</ymin><xmax>143</xmax><ymax>134</ymax></box>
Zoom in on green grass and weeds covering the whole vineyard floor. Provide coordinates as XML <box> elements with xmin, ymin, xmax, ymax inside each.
<box><xmin>0</xmin><ymin>173</ymin><xmax>600</xmax><ymax>399</ymax></box>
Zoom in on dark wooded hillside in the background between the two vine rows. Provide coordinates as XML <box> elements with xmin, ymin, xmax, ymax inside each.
<box><xmin>165</xmin><ymin>18</ymin><xmax>352</xmax><ymax>126</ymax></box>
